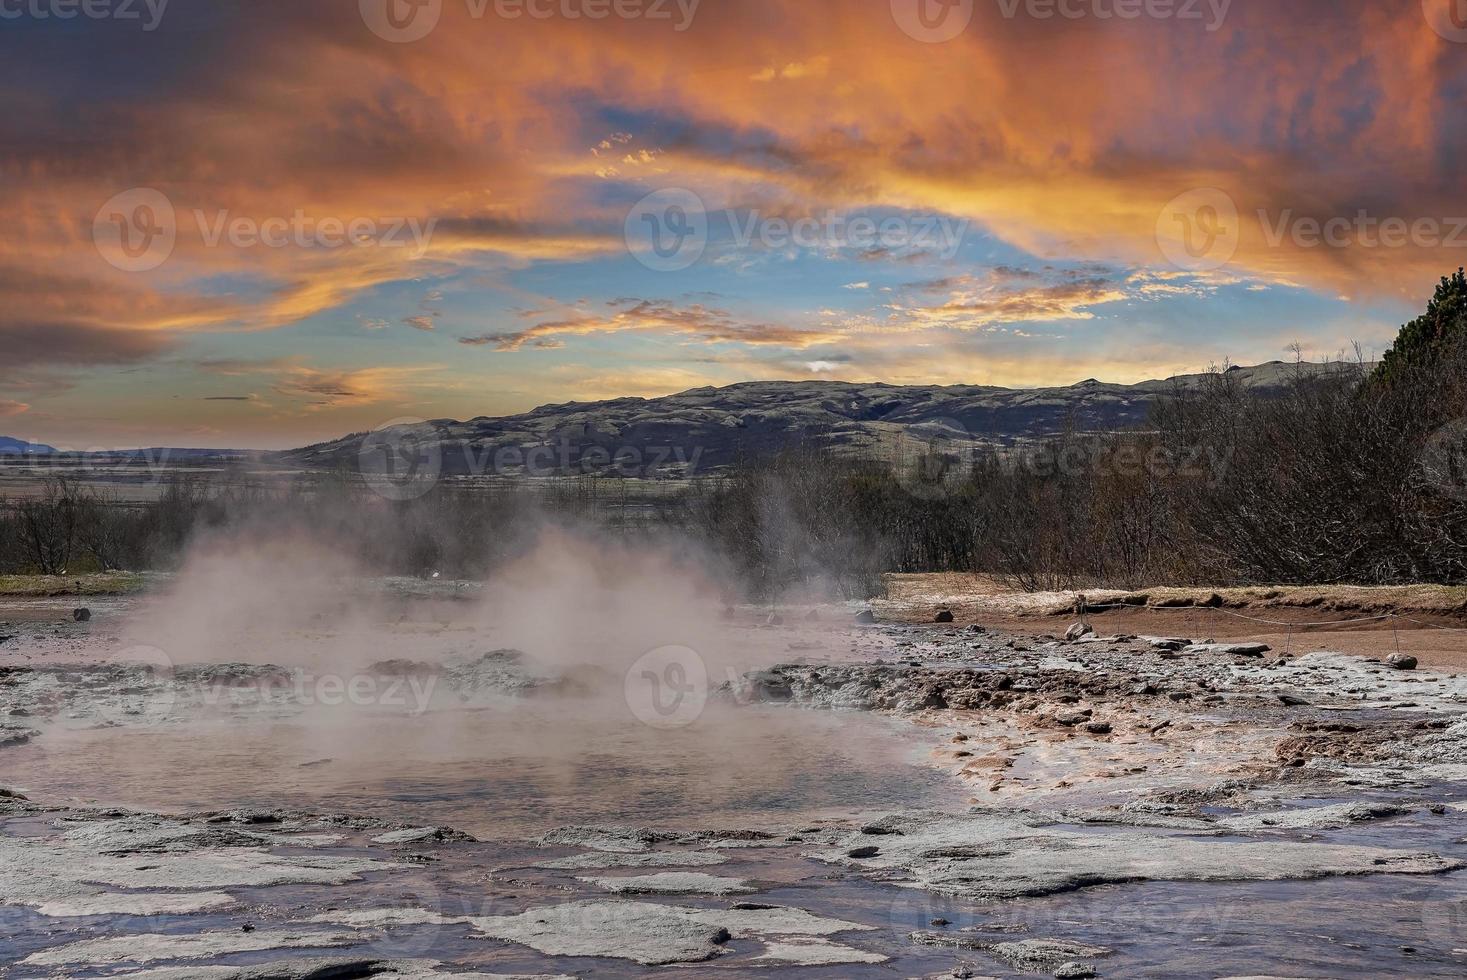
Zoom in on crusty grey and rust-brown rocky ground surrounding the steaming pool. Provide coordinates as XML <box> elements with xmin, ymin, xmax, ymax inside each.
<box><xmin>0</xmin><ymin>607</ymin><xmax>1467</xmax><ymax>980</ymax></box>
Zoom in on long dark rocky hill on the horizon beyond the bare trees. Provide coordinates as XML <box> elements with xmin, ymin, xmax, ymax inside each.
<box><xmin>277</xmin><ymin>361</ymin><xmax>1343</xmax><ymax>475</ymax></box>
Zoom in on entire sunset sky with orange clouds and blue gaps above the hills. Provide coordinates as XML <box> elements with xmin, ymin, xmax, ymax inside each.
<box><xmin>0</xmin><ymin>0</ymin><xmax>1467</xmax><ymax>449</ymax></box>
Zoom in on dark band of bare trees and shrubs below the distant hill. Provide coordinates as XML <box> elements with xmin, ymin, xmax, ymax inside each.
<box><xmin>11</xmin><ymin>270</ymin><xmax>1467</xmax><ymax>599</ymax></box>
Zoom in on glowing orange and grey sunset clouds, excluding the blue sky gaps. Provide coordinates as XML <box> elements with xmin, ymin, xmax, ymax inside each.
<box><xmin>0</xmin><ymin>0</ymin><xmax>1467</xmax><ymax>440</ymax></box>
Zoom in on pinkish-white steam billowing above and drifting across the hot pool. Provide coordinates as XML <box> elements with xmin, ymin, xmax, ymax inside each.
<box><xmin>28</xmin><ymin>525</ymin><xmax>938</xmax><ymax>833</ymax></box>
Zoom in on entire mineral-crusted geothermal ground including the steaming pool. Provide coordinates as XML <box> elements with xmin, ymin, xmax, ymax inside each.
<box><xmin>0</xmin><ymin>601</ymin><xmax>1467</xmax><ymax>980</ymax></box>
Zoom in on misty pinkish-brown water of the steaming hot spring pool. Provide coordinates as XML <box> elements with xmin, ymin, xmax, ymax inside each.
<box><xmin>4</xmin><ymin>701</ymin><xmax>961</xmax><ymax>838</ymax></box>
